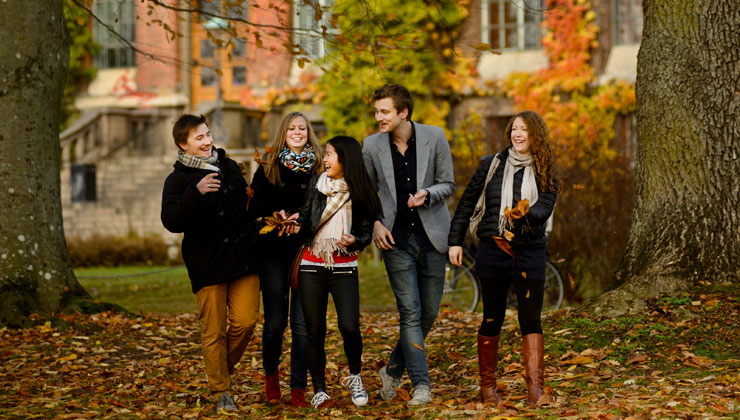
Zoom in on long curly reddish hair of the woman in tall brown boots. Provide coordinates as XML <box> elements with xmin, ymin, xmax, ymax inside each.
<box><xmin>504</xmin><ymin>111</ymin><xmax>555</xmax><ymax>191</ymax></box>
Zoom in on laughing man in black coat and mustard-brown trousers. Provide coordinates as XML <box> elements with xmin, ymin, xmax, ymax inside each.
<box><xmin>161</xmin><ymin>114</ymin><xmax>259</xmax><ymax>411</ymax></box>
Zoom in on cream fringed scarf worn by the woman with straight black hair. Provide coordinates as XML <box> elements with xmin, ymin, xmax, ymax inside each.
<box><xmin>311</xmin><ymin>172</ymin><xmax>357</xmax><ymax>268</ymax></box>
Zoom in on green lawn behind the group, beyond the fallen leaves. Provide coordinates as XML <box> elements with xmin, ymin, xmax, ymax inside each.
<box><xmin>75</xmin><ymin>259</ymin><xmax>396</xmax><ymax>313</ymax></box>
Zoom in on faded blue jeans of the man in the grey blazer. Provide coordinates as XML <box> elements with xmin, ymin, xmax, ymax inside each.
<box><xmin>383</xmin><ymin>235</ymin><xmax>446</xmax><ymax>388</ymax></box>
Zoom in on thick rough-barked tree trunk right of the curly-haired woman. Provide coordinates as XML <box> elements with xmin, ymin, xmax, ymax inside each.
<box><xmin>589</xmin><ymin>0</ymin><xmax>740</xmax><ymax>316</ymax></box>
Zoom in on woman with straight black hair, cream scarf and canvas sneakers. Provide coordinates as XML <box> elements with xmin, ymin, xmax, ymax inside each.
<box><xmin>292</xmin><ymin>136</ymin><xmax>381</xmax><ymax>408</ymax></box>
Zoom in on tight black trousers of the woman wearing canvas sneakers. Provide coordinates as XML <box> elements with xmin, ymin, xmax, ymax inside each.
<box><xmin>298</xmin><ymin>265</ymin><xmax>362</xmax><ymax>392</ymax></box>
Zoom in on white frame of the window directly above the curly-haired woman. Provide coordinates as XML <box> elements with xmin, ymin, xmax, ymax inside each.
<box><xmin>481</xmin><ymin>0</ymin><xmax>545</xmax><ymax>51</ymax></box>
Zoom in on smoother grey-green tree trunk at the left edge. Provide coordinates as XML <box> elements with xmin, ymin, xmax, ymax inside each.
<box><xmin>0</xmin><ymin>0</ymin><xmax>86</xmax><ymax>327</ymax></box>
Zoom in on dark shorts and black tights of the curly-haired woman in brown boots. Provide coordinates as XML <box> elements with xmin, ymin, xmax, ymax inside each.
<box><xmin>475</xmin><ymin>236</ymin><xmax>547</xmax><ymax>337</ymax></box>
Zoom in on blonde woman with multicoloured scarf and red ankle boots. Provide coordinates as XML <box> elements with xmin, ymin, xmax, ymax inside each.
<box><xmin>249</xmin><ymin>112</ymin><xmax>323</xmax><ymax>407</ymax></box>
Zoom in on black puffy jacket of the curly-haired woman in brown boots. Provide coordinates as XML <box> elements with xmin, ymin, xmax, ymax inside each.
<box><xmin>447</xmin><ymin>149</ymin><xmax>557</xmax><ymax>248</ymax></box>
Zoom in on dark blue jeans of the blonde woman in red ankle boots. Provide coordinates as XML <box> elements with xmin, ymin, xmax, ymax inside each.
<box><xmin>259</xmin><ymin>255</ymin><xmax>308</xmax><ymax>389</ymax></box>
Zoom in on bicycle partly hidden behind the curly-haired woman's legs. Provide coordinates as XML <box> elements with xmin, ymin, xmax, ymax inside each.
<box><xmin>441</xmin><ymin>241</ymin><xmax>563</xmax><ymax>312</ymax></box>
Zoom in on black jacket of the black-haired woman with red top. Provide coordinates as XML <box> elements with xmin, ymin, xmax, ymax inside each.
<box><xmin>298</xmin><ymin>174</ymin><xmax>377</xmax><ymax>252</ymax></box>
